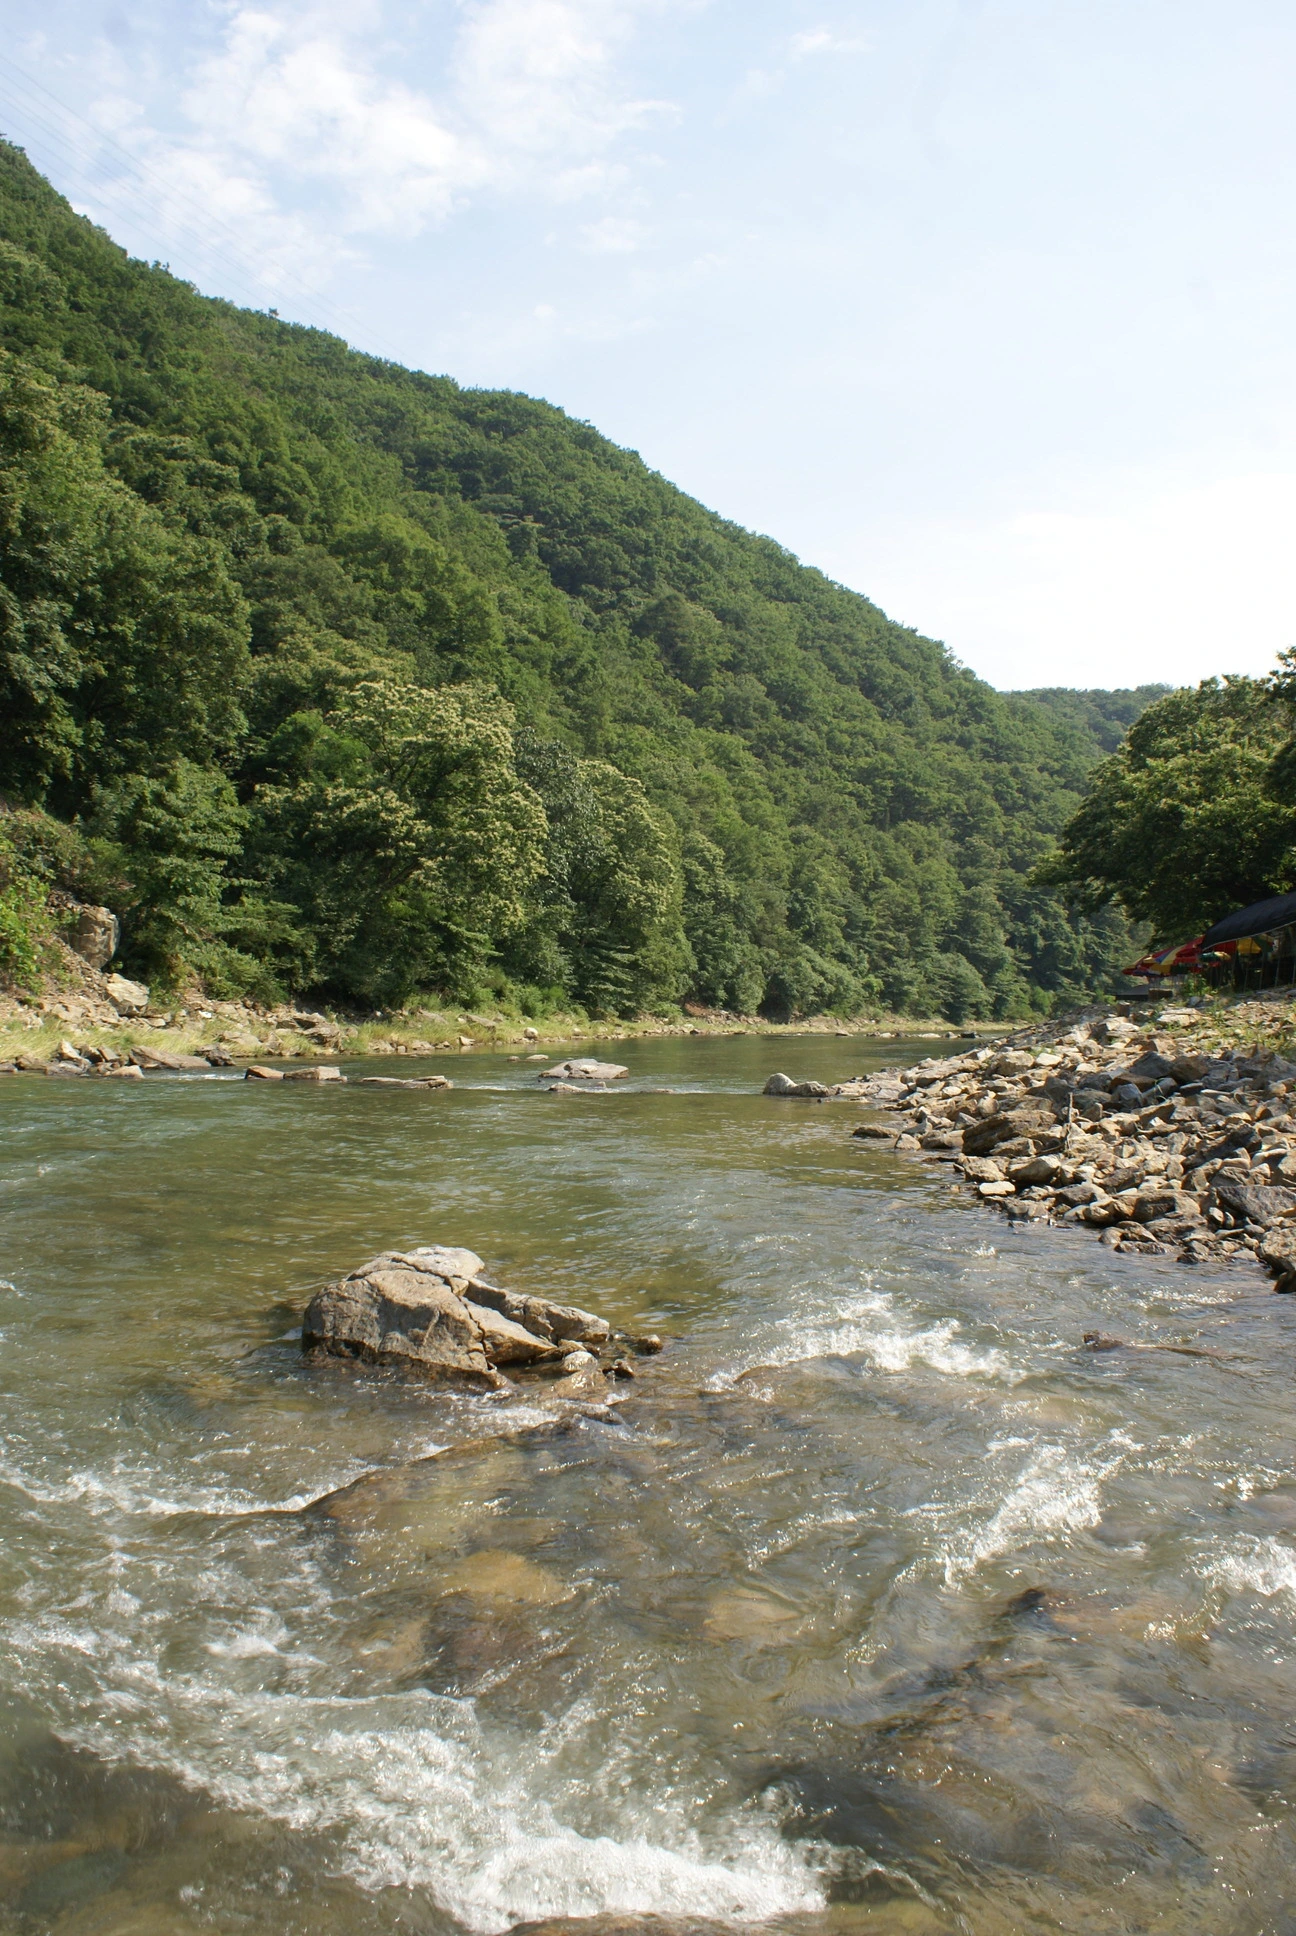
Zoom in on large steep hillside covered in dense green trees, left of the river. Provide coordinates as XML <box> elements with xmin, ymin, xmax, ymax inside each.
<box><xmin>0</xmin><ymin>145</ymin><xmax>1127</xmax><ymax>1018</ymax></box>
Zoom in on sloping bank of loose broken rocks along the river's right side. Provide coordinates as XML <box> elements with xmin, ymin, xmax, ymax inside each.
<box><xmin>844</xmin><ymin>999</ymin><xmax>1296</xmax><ymax>1291</ymax></box>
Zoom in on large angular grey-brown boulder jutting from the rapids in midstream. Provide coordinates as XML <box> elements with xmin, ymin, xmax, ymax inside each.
<box><xmin>302</xmin><ymin>1245</ymin><xmax>661</xmax><ymax>1398</ymax></box>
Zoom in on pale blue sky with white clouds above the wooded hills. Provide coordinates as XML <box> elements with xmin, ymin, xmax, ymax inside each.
<box><xmin>0</xmin><ymin>0</ymin><xmax>1296</xmax><ymax>687</ymax></box>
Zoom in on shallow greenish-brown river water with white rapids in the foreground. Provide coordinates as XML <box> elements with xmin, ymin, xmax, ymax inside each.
<box><xmin>0</xmin><ymin>1038</ymin><xmax>1296</xmax><ymax>1936</ymax></box>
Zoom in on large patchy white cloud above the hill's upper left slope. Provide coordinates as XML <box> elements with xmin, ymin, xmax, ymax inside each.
<box><xmin>73</xmin><ymin>0</ymin><xmax>690</xmax><ymax>288</ymax></box>
